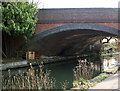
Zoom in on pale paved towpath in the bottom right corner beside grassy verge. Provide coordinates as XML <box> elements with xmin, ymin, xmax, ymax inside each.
<box><xmin>90</xmin><ymin>72</ymin><xmax>120</xmax><ymax>91</ymax></box>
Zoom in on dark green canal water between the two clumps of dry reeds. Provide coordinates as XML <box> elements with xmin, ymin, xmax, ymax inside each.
<box><xmin>44</xmin><ymin>61</ymin><xmax>77</xmax><ymax>89</ymax></box>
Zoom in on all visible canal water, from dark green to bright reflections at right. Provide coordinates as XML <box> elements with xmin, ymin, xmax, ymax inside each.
<box><xmin>3</xmin><ymin>56</ymin><xmax>118</xmax><ymax>89</ymax></box>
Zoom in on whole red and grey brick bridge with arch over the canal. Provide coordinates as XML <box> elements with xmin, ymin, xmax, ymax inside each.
<box><xmin>23</xmin><ymin>8</ymin><xmax>119</xmax><ymax>56</ymax></box>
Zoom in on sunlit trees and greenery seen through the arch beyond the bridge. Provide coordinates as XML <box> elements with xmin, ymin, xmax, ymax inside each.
<box><xmin>82</xmin><ymin>37</ymin><xmax>120</xmax><ymax>56</ymax></box>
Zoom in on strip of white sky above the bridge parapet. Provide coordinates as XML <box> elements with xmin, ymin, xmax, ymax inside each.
<box><xmin>34</xmin><ymin>0</ymin><xmax>120</xmax><ymax>8</ymax></box>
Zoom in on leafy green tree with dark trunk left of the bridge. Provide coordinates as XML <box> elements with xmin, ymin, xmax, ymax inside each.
<box><xmin>2</xmin><ymin>2</ymin><xmax>38</xmax><ymax>57</ymax></box>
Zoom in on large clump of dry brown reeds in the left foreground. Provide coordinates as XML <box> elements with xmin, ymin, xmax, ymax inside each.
<box><xmin>2</xmin><ymin>63</ymin><xmax>55</xmax><ymax>89</ymax></box>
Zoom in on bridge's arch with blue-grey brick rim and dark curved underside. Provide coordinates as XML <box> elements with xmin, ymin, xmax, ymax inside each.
<box><xmin>23</xmin><ymin>23</ymin><xmax>118</xmax><ymax>55</ymax></box>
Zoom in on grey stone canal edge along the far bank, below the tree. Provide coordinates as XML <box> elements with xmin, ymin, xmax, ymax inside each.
<box><xmin>0</xmin><ymin>57</ymin><xmax>79</xmax><ymax>70</ymax></box>
